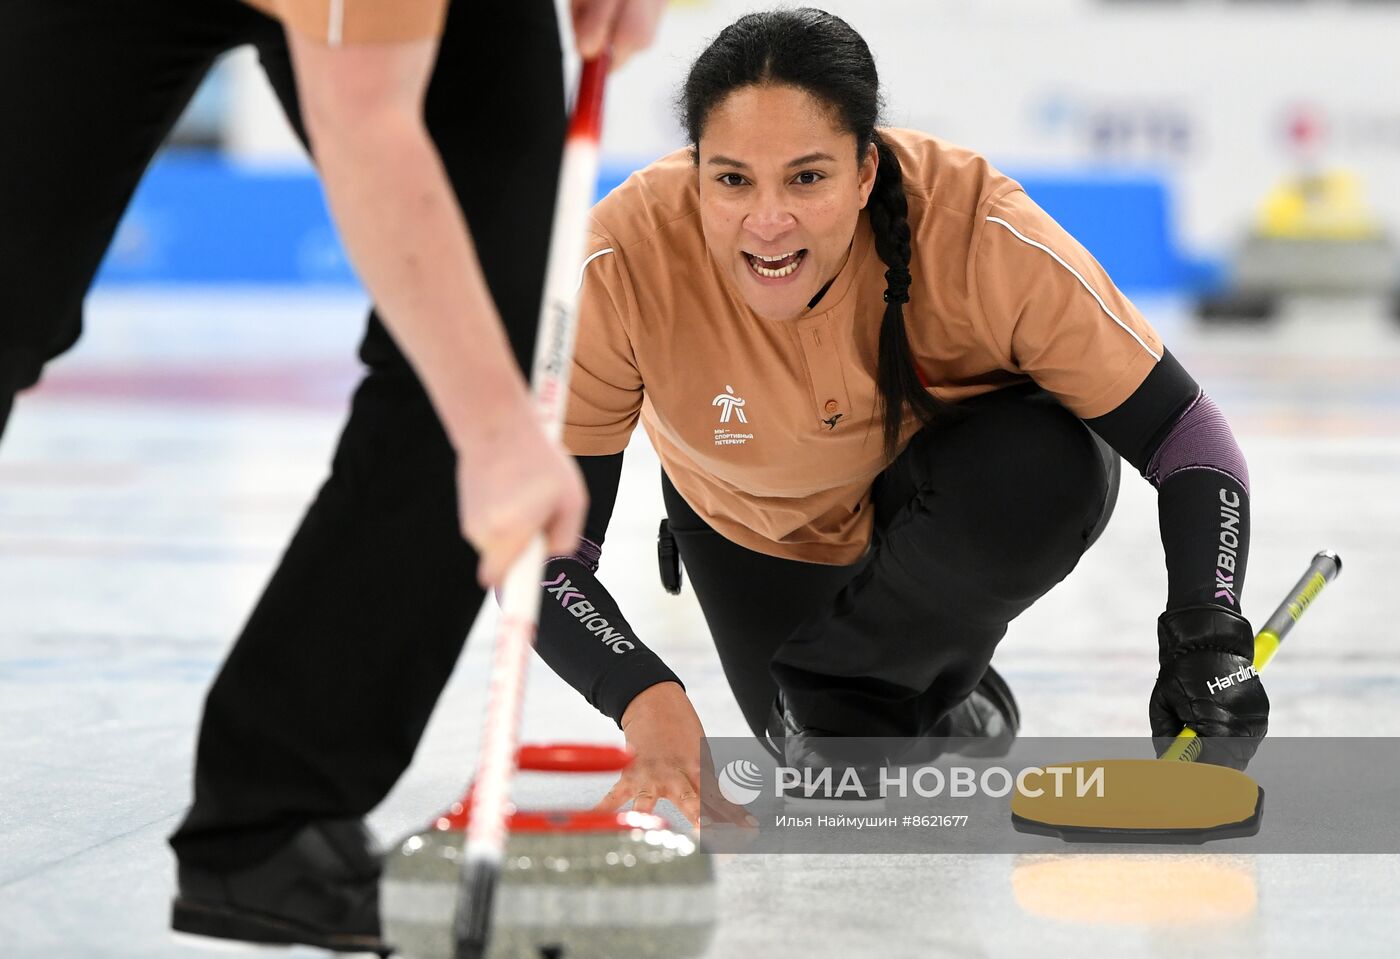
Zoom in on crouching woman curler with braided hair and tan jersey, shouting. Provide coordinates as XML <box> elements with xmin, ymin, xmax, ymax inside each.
<box><xmin>526</xmin><ymin>8</ymin><xmax>1268</xmax><ymax>819</ymax></box>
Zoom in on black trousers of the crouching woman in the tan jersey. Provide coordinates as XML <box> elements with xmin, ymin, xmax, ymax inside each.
<box><xmin>662</xmin><ymin>388</ymin><xmax>1120</xmax><ymax>741</ymax></box>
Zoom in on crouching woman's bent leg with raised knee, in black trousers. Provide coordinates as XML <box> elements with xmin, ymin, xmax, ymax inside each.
<box><xmin>773</xmin><ymin>391</ymin><xmax>1117</xmax><ymax>736</ymax></box>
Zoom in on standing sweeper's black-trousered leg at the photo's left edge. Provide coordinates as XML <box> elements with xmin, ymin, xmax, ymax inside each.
<box><xmin>0</xmin><ymin>0</ymin><xmax>260</xmax><ymax>434</ymax></box>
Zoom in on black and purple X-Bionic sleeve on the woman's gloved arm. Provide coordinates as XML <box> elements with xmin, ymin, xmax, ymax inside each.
<box><xmin>1086</xmin><ymin>351</ymin><xmax>1249</xmax><ymax>612</ymax></box>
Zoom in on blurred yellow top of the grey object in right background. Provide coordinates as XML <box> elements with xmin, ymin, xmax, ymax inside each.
<box><xmin>1257</xmin><ymin>169</ymin><xmax>1383</xmax><ymax>241</ymax></box>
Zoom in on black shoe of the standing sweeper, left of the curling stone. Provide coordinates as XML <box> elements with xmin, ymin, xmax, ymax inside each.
<box><xmin>171</xmin><ymin>819</ymin><xmax>393</xmax><ymax>956</ymax></box>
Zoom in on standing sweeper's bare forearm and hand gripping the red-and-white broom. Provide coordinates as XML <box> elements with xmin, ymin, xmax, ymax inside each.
<box><xmin>288</xmin><ymin>31</ymin><xmax>585</xmax><ymax>584</ymax></box>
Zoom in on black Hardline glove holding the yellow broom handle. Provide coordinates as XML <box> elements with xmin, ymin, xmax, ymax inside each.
<box><xmin>1148</xmin><ymin>605</ymin><xmax>1268</xmax><ymax>769</ymax></box>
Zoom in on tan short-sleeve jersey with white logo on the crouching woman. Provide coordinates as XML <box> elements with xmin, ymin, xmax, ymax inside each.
<box><xmin>564</xmin><ymin>130</ymin><xmax>1162</xmax><ymax>564</ymax></box>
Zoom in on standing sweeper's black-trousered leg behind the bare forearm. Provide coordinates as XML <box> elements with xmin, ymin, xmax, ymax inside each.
<box><xmin>171</xmin><ymin>0</ymin><xmax>564</xmax><ymax>873</ymax></box>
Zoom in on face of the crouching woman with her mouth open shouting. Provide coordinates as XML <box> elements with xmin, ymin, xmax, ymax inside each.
<box><xmin>696</xmin><ymin>85</ymin><xmax>878</xmax><ymax>319</ymax></box>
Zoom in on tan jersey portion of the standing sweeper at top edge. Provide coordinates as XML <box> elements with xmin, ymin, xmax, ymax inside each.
<box><xmin>246</xmin><ymin>0</ymin><xmax>449</xmax><ymax>46</ymax></box>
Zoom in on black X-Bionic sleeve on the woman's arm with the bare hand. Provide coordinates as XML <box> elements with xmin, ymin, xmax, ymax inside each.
<box><xmin>535</xmin><ymin>454</ymin><xmax>680</xmax><ymax>725</ymax></box>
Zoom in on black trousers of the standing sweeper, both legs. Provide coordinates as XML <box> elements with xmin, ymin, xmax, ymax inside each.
<box><xmin>0</xmin><ymin>0</ymin><xmax>564</xmax><ymax>868</ymax></box>
